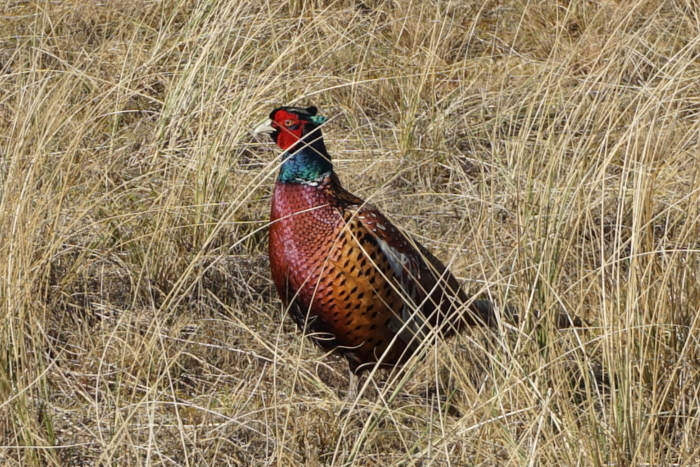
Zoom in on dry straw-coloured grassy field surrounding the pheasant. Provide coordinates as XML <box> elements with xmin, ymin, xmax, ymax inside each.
<box><xmin>0</xmin><ymin>0</ymin><xmax>700</xmax><ymax>467</ymax></box>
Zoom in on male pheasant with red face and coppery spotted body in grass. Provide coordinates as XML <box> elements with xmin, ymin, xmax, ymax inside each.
<box><xmin>255</xmin><ymin>107</ymin><xmax>516</xmax><ymax>394</ymax></box>
